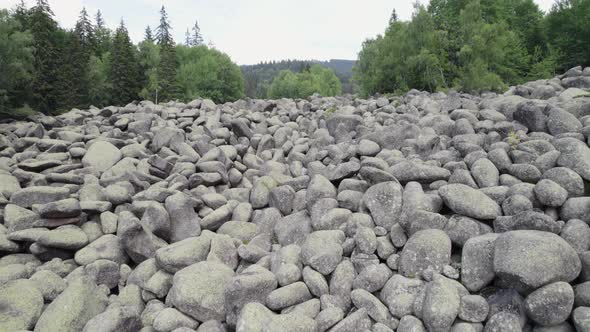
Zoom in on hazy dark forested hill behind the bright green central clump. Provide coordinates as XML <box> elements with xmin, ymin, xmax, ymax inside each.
<box><xmin>241</xmin><ymin>59</ymin><xmax>356</xmax><ymax>98</ymax></box>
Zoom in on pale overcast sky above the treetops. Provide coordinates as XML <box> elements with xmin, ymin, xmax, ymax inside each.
<box><xmin>0</xmin><ymin>0</ymin><xmax>554</xmax><ymax>64</ymax></box>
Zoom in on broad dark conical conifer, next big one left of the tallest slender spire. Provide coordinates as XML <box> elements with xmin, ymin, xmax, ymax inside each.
<box><xmin>109</xmin><ymin>20</ymin><xmax>138</xmax><ymax>105</ymax></box>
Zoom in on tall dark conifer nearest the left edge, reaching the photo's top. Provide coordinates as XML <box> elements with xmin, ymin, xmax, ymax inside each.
<box><xmin>30</xmin><ymin>0</ymin><xmax>59</xmax><ymax>113</ymax></box>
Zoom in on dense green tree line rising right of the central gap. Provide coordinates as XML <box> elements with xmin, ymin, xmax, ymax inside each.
<box><xmin>354</xmin><ymin>0</ymin><xmax>590</xmax><ymax>95</ymax></box>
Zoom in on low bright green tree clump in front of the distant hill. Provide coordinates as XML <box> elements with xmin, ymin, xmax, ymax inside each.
<box><xmin>269</xmin><ymin>64</ymin><xmax>342</xmax><ymax>99</ymax></box>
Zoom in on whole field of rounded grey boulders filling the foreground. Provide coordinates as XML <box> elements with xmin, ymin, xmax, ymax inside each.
<box><xmin>0</xmin><ymin>68</ymin><xmax>590</xmax><ymax>332</ymax></box>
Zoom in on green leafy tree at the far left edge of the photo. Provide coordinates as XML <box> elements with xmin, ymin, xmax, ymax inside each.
<box><xmin>0</xmin><ymin>9</ymin><xmax>33</xmax><ymax>116</ymax></box>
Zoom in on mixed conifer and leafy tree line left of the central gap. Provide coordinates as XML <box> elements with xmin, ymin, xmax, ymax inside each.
<box><xmin>0</xmin><ymin>0</ymin><xmax>244</xmax><ymax>116</ymax></box>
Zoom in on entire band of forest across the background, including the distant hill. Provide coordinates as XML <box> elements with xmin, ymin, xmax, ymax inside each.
<box><xmin>0</xmin><ymin>0</ymin><xmax>590</xmax><ymax>117</ymax></box>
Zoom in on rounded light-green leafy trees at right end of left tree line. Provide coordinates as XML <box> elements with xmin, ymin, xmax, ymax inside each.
<box><xmin>176</xmin><ymin>45</ymin><xmax>244</xmax><ymax>103</ymax></box>
